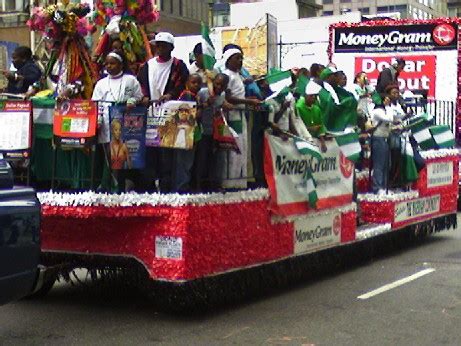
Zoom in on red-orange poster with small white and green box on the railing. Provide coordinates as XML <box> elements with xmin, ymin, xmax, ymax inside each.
<box><xmin>53</xmin><ymin>100</ymin><xmax>98</xmax><ymax>147</ymax></box>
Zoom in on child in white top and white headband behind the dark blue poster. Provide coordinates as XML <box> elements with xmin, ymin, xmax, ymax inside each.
<box><xmin>91</xmin><ymin>51</ymin><xmax>143</xmax><ymax>192</ymax></box>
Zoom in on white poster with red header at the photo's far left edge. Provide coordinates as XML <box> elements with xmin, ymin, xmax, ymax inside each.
<box><xmin>0</xmin><ymin>101</ymin><xmax>32</xmax><ymax>160</ymax></box>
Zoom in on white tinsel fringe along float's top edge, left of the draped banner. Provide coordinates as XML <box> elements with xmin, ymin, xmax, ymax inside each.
<box><xmin>37</xmin><ymin>189</ymin><xmax>269</xmax><ymax>207</ymax></box>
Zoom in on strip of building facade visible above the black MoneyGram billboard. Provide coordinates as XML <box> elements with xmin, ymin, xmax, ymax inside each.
<box><xmin>319</xmin><ymin>0</ymin><xmax>448</xmax><ymax>19</ymax></box>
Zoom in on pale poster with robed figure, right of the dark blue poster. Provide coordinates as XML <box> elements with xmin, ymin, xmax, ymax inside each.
<box><xmin>146</xmin><ymin>101</ymin><xmax>197</xmax><ymax>150</ymax></box>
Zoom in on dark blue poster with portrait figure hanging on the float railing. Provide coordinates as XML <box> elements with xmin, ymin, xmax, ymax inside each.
<box><xmin>109</xmin><ymin>105</ymin><xmax>147</xmax><ymax>170</ymax></box>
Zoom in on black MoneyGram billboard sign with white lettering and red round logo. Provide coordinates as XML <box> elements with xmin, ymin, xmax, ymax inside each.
<box><xmin>334</xmin><ymin>23</ymin><xmax>458</xmax><ymax>53</ymax></box>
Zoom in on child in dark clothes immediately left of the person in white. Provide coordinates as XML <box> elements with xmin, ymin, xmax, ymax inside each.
<box><xmin>193</xmin><ymin>73</ymin><xmax>233</xmax><ymax>191</ymax></box>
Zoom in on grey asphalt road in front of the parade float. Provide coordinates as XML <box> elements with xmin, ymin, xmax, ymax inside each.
<box><xmin>0</xmin><ymin>224</ymin><xmax>461</xmax><ymax>345</ymax></box>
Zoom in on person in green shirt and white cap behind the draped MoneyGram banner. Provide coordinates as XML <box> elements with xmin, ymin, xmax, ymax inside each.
<box><xmin>296</xmin><ymin>80</ymin><xmax>327</xmax><ymax>152</ymax></box>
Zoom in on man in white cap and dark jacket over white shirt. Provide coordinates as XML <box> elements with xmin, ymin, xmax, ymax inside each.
<box><xmin>138</xmin><ymin>32</ymin><xmax>189</xmax><ymax>192</ymax></box>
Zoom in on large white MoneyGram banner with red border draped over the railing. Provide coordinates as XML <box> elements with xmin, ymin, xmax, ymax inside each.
<box><xmin>264</xmin><ymin>134</ymin><xmax>354</xmax><ymax>216</ymax></box>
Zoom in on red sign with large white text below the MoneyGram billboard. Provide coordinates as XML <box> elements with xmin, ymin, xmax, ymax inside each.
<box><xmin>355</xmin><ymin>55</ymin><xmax>436</xmax><ymax>97</ymax></box>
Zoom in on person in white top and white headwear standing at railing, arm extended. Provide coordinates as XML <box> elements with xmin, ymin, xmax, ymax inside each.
<box><xmin>223</xmin><ymin>48</ymin><xmax>261</xmax><ymax>189</ymax></box>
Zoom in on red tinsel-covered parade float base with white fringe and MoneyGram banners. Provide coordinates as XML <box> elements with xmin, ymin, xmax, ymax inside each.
<box><xmin>0</xmin><ymin>16</ymin><xmax>459</xmax><ymax>309</ymax></box>
